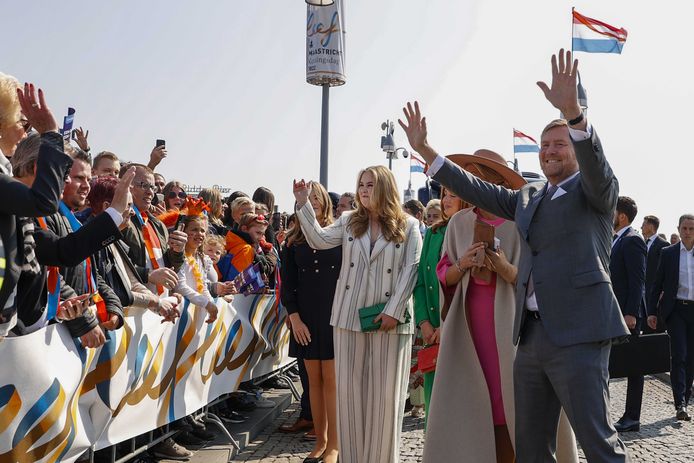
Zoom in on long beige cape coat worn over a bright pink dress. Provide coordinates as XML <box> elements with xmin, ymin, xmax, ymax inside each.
<box><xmin>423</xmin><ymin>209</ymin><xmax>578</xmax><ymax>463</ymax></box>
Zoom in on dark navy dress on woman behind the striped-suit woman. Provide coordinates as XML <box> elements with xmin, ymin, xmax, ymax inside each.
<box><xmin>281</xmin><ymin>243</ymin><xmax>342</xmax><ymax>360</ymax></box>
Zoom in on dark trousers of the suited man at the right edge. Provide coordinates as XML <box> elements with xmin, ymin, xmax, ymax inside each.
<box><xmin>665</xmin><ymin>302</ymin><xmax>694</xmax><ymax>407</ymax></box>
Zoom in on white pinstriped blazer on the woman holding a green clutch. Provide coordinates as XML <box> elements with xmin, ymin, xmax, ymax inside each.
<box><xmin>296</xmin><ymin>202</ymin><xmax>422</xmax><ymax>334</ymax></box>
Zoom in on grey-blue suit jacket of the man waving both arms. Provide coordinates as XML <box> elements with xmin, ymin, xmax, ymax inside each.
<box><xmin>434</xmin><ymin>130</ymin><xmax>629</xmax><ymax>346</ymax></box>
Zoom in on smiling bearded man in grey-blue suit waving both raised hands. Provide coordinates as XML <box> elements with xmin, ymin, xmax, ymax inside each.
<box><xmin>400</xmin><ymin>50</ymin><xmax>629</xmax><ymax>463</ymax></box>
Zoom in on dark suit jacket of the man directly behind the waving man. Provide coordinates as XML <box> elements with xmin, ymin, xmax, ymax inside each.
<box><xmin>610</xmin><ymin>227</ymin><xmax>646</xmax><ymax>318</ymax></box>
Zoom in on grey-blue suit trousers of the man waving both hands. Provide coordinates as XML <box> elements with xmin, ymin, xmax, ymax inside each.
<box><xmin>513</xmin><ymin>317</ymin><xmax>629</xmax><ymax>463</ymax></box>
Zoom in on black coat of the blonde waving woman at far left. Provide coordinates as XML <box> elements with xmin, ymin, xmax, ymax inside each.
<box><xmin>0</xmin><ymin>132</ymin><xmax>72</xmax><ymax>330</ymax></box>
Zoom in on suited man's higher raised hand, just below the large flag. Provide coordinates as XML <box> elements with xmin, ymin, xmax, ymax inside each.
<box><xmin>537</xmin><ymin>48</ymin><xmax>581</xmax><ymax>120</ymax></box>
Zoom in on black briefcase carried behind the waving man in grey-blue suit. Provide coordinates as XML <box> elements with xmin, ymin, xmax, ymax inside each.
<box><xmin>610</xmin><ymin>333</ymin><xmax>670</xmax><ymax>379</ymax></box>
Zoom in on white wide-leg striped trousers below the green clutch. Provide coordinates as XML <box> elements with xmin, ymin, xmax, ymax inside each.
<box><xmin>333</xmin><ymin>328</ymin><xmax>412</xmax><ymax>463</ymax></box>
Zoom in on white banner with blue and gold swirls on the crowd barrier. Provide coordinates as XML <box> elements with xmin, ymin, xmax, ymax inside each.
<box><xmin>0</xmin><ymin>294</ymin><xmax>291</xmax><ymax>463</ymax></box>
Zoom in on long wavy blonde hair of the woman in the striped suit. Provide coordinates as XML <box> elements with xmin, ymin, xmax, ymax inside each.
<box><xmin>349</xmin><ymin>166</ymin><xmax>407</xmax><ymax>243</ymax></box>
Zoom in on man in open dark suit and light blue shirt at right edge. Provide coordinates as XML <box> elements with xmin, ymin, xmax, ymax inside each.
<box><xmin>648</xmin><ymin>214</ymin><xmax>694</xmax><ymax>421</ymax></box>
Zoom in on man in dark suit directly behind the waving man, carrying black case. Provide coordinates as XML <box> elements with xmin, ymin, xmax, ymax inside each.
<box><xmin>610</xmin><ymin>196</ymin><xmax>646</xmax><ymax>432</ymax></box>
